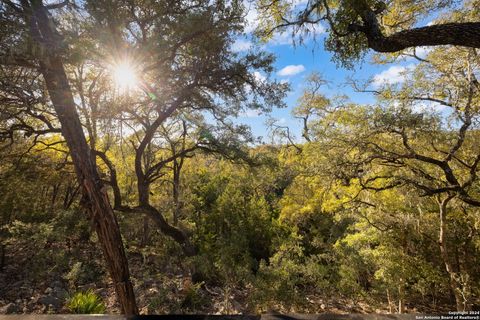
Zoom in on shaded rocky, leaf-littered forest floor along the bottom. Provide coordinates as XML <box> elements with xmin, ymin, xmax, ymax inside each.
<box><xmin>0</xmin><ymin>236</ymin><xmax>442</xmax><ymax>314</ymax></box>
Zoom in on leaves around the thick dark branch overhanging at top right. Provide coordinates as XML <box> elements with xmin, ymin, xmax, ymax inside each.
<box><xmin>256</xmin><ymin>0</ymin><xmax>470</xmax><ymax>68</ymax></box>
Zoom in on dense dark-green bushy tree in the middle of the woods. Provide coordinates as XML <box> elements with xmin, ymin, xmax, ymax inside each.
<box><xmin>188</xmin><ymin>163</ymin><xmax>275</xmax><ymax>283</ymax></box>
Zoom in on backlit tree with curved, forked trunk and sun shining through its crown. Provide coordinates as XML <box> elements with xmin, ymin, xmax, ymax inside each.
<box><xmin>72</xmin><ymin>1</ymin><xmax>285</xmax><ymax>255</ymax></box>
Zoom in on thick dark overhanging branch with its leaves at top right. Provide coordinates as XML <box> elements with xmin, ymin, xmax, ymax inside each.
<box><xmin>258</xmin><ymin>0</ymin><xmax>480</xmax><ymax>66</ymax></box>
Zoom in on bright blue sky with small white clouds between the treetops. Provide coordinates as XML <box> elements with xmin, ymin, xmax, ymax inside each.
<box><xmin>233</xmin><ymin>4</ymin><xmax>430</xmax><ymax>142</ymax></box>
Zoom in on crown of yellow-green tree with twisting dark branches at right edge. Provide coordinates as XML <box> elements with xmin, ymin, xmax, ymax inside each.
<box><xmin>348</xmin><ymin>49</ymin><xmax>480</xmax><ymax>206</ymax></box>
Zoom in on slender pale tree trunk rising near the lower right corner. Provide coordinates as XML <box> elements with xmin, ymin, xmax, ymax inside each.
<box><xmin>438</xmin><ymin>196</ymin><xmax>465</xmax><ymax>311</ymax></box>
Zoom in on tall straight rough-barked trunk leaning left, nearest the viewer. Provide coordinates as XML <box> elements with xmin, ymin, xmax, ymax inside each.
<box><xmin>22</xmin><ymin>0</ymin><xmax>138</xmax><ymax>314</ymax></box>
